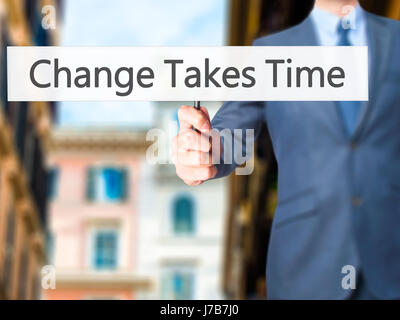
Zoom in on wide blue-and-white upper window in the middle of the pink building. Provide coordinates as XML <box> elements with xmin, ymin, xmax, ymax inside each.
<box><xmin>86</xmin><ymin>167</ymin><xmax>128</xmax><ymax>202</ymax></box>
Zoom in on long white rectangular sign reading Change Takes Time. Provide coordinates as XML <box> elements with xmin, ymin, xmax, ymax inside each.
<box><xmin>7</xmin><ymin>46</ymin><xmax>368</xmax><ymax>101</ymax></box>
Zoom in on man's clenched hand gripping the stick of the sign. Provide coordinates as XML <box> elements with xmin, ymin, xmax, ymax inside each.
<box><xmin>172</xmin><ymin>106</ymin><xmax>220</xmax><ymax>186</ymax></box>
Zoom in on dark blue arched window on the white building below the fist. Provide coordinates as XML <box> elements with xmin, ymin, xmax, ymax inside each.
<box><xmin>172</xmin><ymin>195</ymin><xmax>195</xmax><ymax>235</ymax></box>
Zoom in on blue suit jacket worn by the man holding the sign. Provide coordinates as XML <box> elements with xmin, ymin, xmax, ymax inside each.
<box><xmin>212</xmin><ymin>13</ymin><xmax>400</xmax><ymax>299</ymax></box>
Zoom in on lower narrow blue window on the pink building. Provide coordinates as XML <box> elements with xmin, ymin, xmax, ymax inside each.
<box><xmin>93</xmin><ymin>230</ymin><xmax>118</xmax><ymax>270</ymax></box>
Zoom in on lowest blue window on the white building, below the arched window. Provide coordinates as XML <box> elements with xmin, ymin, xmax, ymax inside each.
<box><xmin>161</xmin><ymin>267</ymin><xmax>195</xmax><ymax>300</ymax></box>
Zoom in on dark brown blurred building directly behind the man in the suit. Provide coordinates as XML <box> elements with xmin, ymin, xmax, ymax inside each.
<box><xmin>223</xmin><ymin>0</ymin><xmax>400</xmax><ymax>299</ymax></box>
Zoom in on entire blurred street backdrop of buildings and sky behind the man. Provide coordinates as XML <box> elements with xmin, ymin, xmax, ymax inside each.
<box><xmin>0</xmin><ymin>0</ymin><xmax>400</xmax><ymax>300</ymax></box>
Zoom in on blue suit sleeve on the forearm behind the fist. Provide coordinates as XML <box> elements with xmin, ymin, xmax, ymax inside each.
<box><xmin>211</xmin><ymin>101</ymin><xmax>265</xmax><ymax>179</ymax></box>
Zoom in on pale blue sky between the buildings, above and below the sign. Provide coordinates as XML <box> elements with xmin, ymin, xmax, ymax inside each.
<box><xmin>58</xmin><ymin>0</ymin><xmax>229</xmax><ymax>128</ymax></box>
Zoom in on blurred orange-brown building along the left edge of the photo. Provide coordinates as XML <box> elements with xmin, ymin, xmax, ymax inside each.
<box><xmin>0</xmin><ymin>0</ymin><xmax>58</xmax><ymax>299</ymax></box>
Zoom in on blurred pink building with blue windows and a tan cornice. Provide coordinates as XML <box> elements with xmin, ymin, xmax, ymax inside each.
<box><xmin>44</xmin><ymin>128</ymin><xmax>150</xmax><ymax>299</ymax></box>
